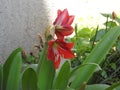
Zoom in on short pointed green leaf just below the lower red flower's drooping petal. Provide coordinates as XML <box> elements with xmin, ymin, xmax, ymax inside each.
<box><xmin>54</xmin><ymin>61</ymin><xmax>70</xmax><ymax>90</ymax></box>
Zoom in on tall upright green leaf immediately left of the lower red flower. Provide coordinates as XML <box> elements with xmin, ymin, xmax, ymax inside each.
<box><xmin>37</xmin><ymin>44</ymin><xmax>55</xmax><ymax>90</ymax></box>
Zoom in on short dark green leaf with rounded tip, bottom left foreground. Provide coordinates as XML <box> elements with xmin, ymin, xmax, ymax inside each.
<box><xmin>22</xmin><ymin>68</ymin><xmax>37</xmax><ymax>90</ymax></box>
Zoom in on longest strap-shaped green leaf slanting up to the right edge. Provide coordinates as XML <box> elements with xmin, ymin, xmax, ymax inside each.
<box><xmin>70</xmin><ymin>26</ymin><xmax>120</xmax><ymax>88</ymax></box>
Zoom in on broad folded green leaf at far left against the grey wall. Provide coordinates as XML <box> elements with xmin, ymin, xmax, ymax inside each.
<box><xmin>3</xmin><ymin>48</ymin><xmax>22</xmax><ymax>90</ymax></box>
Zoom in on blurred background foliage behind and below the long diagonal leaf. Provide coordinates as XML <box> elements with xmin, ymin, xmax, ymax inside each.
<box><xmin>71</xmin><ymin>11</ymin><xmax>120</xmax><ymax>85</ymax></box>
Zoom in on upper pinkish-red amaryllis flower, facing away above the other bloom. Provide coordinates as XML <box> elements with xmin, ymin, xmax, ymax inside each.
<box><xmin>53</xmin><ymin>9</ymin><xmax>74</xmax><ymax>38</ymax></box>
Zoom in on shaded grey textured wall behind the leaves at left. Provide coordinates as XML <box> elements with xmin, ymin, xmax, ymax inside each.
<box><xmin>0</xmin><ymin>0</ymin><xmax>50</xmax><ymax>62</ymax></box>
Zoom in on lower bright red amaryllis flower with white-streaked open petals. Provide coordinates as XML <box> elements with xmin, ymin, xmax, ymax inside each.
<box><xmin>48</xmin><ymin>39</ymin><xmax>75</xmax><ymax>69</ymax></box>
